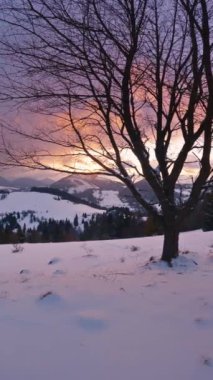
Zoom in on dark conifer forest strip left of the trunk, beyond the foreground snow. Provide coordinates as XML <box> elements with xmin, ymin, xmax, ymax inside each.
<box><xmin>0</xmin><ymin>208</ymin><xmax>147</xmax><ymax>244</ymax></box>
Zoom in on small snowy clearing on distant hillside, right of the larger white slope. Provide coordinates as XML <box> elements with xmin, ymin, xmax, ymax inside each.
<box><xmin>93</xmin><ymin>190</ymin><xmax>129</xmax><ymax>207</ymax></box>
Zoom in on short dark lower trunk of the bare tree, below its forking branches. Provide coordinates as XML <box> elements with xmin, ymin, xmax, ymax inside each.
<box><xmin>161</xmin><ymin>224</ymin><xmax>179</xmax><ymax>263</ymax></box>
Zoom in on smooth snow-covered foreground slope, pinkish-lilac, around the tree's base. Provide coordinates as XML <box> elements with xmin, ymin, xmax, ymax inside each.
<box><xmin>0</xmin><ymin>231</ymin><xmax>213</xmax><ymax>380</ymax></box>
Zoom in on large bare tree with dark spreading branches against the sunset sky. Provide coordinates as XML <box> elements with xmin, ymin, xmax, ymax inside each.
<box><xmin>1</xmin><ymin>0</ymin><xmax>213</xmax><ymax>262</ymax></box>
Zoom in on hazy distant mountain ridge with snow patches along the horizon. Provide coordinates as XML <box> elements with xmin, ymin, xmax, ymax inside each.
<box><xmin>0</xmin><ymin>174</ymin><xmax>191</xmax><ymax>212</ymax></box>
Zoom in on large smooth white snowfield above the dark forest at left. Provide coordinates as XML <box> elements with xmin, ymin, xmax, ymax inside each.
<box><xmin>0</xmin><ymin>191</ymin><xmax>103</xmax><ymax>227</ymax></box>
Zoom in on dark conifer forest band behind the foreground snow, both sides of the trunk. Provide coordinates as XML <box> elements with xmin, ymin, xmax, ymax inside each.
<box><xmin>0</xmin><ymin>194</ymin><xmax>210</xmax><ymax>244</ymax></box>
